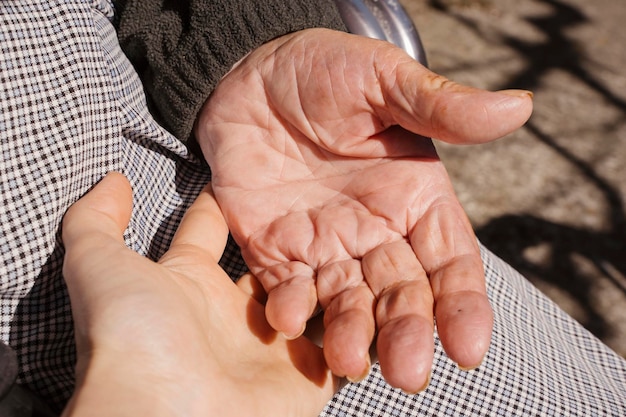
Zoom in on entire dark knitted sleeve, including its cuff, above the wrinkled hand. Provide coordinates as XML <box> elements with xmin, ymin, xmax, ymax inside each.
<box><xmin>116</xmin><ymin>0</ymin><xmax>345</xmax><ymax>140</ymax></box>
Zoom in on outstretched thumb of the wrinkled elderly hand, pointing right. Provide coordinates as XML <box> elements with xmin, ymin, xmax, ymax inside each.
<box><xmin>378</xmin><ymin>52</ymin><xmax>533</xmax><ymax>144</ymax></box>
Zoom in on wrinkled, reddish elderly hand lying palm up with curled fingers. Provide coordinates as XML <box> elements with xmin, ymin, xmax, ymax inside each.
<box><xmin>195</xmin><ymin>29</ymin><xmax>532</xmax><ymax>392</ymax></box>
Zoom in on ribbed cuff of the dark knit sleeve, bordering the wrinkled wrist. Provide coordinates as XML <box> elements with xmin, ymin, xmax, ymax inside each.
<box><xmin>149</xmin><ymin>0</ymin><xmax>346</xmax><ymax>140</ymax></box>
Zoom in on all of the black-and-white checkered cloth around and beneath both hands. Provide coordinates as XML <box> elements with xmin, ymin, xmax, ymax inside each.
<box><xmin>0</xmin><ymin>0</ymin><xmax>626</xmax><ymax>417</ymax></box>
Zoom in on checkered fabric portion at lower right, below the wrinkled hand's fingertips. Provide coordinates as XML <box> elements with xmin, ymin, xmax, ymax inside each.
<box><xmin>322</xmin><ymin>248</ymin><xmax>626</xmax><ymax>417</ymax></box>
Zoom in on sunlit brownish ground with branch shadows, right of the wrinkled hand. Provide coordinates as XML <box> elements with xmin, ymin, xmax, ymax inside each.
<box><xmin>401</xmin><ymin>0</ymin><xmax>626</xmax><ymax>357</ymax></box>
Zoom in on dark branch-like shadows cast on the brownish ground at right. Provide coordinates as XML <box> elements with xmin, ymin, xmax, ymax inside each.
<box><xmin>428</xmin><ymin>0</ymin><xmax>626</xmax><ymax>354</ymax></box>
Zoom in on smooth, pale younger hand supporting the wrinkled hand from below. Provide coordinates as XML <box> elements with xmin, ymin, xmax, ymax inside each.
<box><xmin>63</xmin><ymin>174</ymin><xmax>337</xmax><ymax>417</ymax></box>
